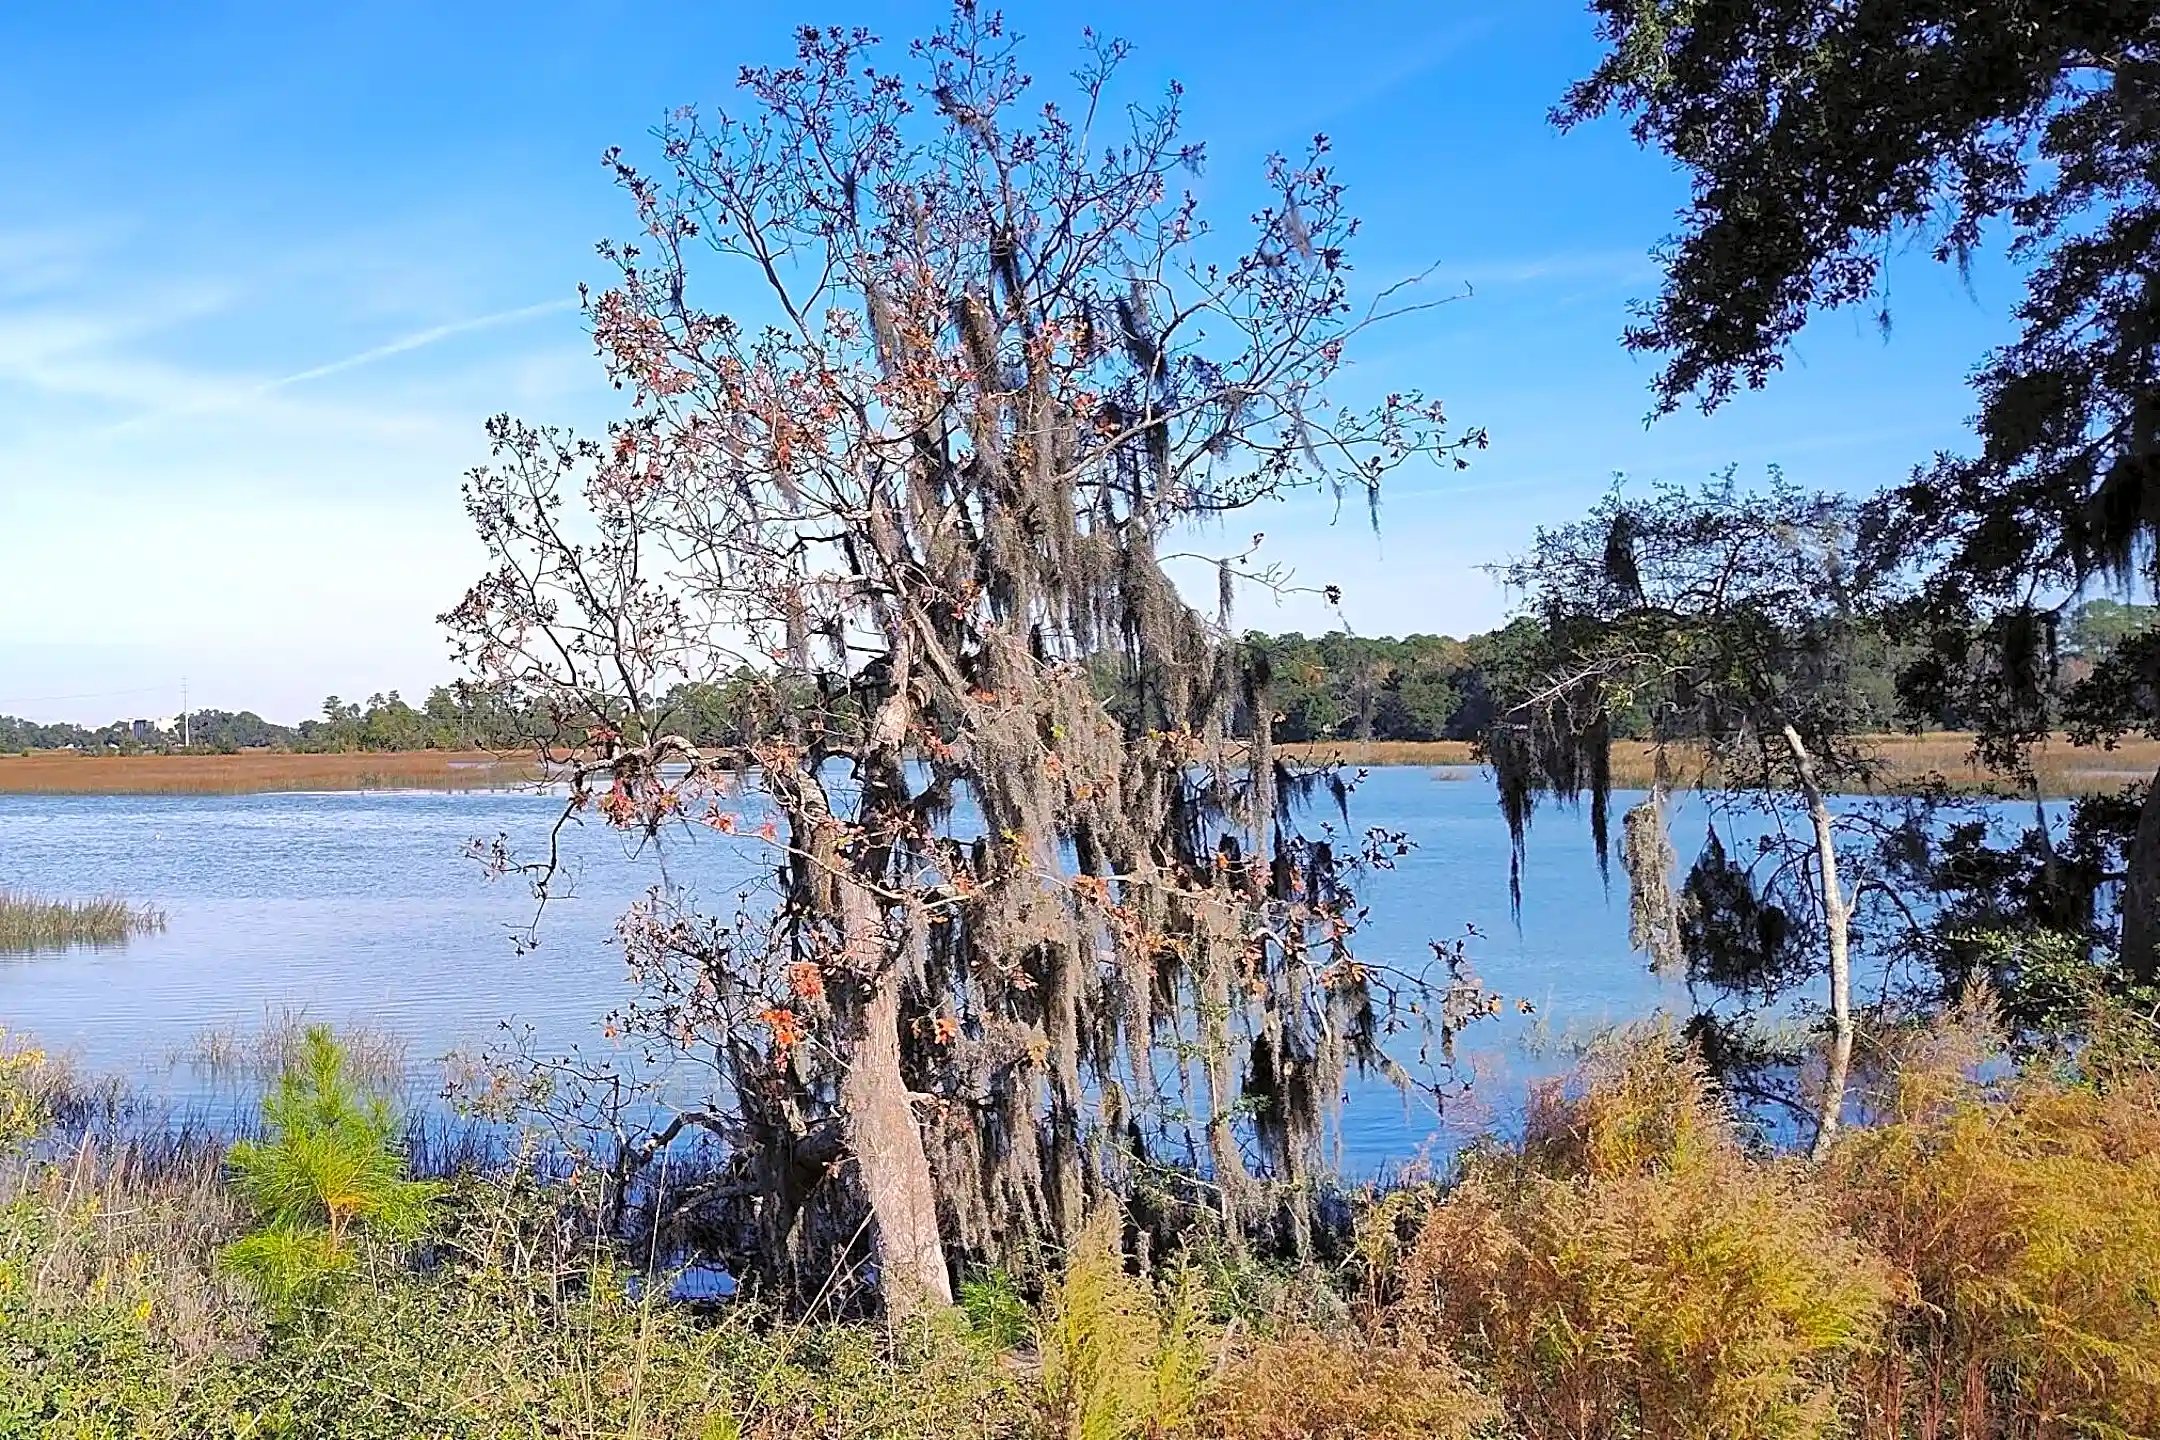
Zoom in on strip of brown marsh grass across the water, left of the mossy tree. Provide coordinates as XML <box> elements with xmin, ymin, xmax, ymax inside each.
<box><xmin>0</xmin><ymin>749</ymin><xmax>538</xmax><ymax>794</ymax></box>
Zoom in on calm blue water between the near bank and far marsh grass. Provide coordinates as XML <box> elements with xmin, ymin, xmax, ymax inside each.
<box><xmin>0</xmin><ymin>769</ymin><xmax>1687</xmax><ymax>1170</ymax></box>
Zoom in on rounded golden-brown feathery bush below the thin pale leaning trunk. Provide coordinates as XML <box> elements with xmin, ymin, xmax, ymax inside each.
<box><xmin>1393</xmin><ymin>1036</ymin><xmax>1892</xmax><ymax>1440</ymax></box>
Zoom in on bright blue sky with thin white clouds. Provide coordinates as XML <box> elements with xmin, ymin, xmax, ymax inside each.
<box><xmin>0</xmin><ymin>0</ymin><xmax>2015</xmax><ymax>721</ymax></box>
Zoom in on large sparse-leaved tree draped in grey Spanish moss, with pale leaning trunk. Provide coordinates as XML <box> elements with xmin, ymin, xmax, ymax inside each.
<box><xmin>445</xmin><ymin>2</ymin><xmax>1482</xmax><ymax>1313</ymax></box>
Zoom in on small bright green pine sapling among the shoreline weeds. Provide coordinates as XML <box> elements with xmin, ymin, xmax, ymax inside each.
<box><xmin>225</xmin><ymin>1025</ymin><xmax>434</xmax><ymax>1302</ymax></box>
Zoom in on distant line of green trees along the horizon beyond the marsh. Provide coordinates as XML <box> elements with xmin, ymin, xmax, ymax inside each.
<box><xmin>0</xmin><ymin>600</ymin><xmax>2160</xmax><ymax>751</ymax></box>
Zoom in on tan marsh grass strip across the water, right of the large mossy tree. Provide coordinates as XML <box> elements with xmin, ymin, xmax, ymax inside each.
<box><xmin>1277</xmin><ymin>730</ymin><xmax>2160</xmax><ymax>794</ymax></box>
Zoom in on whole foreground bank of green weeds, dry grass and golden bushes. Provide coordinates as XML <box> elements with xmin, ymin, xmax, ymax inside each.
<box><xmin>0</xmin><ymin>1025</ymin><xmax>2160</xmax><ymax>1440</ymax></box>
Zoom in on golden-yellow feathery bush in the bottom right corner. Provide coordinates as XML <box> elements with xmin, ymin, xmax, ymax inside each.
<box><xmin>1821</xmin><ymin>1036</ymin><xmax>2160</xmax><ymax>1440</ymax></box>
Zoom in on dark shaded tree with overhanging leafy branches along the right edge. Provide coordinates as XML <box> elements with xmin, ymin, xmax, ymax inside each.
<box><xmin>1557</xmin><ymin>0</ymin><xmax>2160</xmax><ymax>980</ymax></box>
